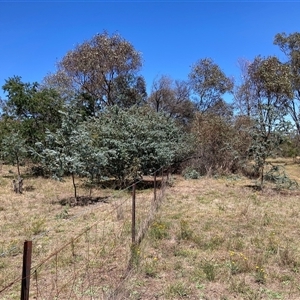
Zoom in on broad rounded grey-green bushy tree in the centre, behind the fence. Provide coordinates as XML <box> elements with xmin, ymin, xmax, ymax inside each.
<box><xmin>88</xmin><ymin>106</ymin><xmax>188</xmax><ymax>185</ymax></box>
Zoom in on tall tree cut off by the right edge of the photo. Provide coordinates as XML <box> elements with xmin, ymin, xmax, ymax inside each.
<box><xmin>274</xmin><ymin>32</ymin><xmax>300</xmax><ymax>138</ymax></box>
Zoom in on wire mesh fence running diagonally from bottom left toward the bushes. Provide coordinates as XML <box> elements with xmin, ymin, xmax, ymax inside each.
<box><xmin>0</xmin><ymin>168</ymin><xmax>168</xmax><ymax>300</ymax></box>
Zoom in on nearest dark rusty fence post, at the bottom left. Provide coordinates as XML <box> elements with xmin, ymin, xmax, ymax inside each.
<box><xmin>21</xmin><ymin>241</ymin><xmax>32</xmax><ymax>300</ymax></box>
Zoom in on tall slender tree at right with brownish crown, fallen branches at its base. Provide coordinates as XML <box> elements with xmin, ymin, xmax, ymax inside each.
<box><xmin>248</xmin><ymin>56</ymin><xmax>292</xmax><ymax>188</ymax></box>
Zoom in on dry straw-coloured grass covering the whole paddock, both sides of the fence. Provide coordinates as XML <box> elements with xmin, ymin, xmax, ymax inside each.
<box><xmin>0</xmin><ymin>163</ymin><xmax>300</xmax><ymax>300</ymax></box>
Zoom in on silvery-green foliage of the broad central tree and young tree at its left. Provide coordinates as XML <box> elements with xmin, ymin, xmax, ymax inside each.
<box><xmin>35</xmin><ymin>106</ymin><xmax>188</xmax><ymax>189</ymax></box>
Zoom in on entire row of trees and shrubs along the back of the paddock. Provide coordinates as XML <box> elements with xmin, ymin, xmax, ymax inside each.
<box><xmin>0</xmin><ymin>32</ymin><xmax>300</xmax><ymax>190</ymax></box>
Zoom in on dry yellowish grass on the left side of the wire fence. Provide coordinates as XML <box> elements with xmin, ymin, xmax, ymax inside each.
<box><xmin>0</xmin><ymin>166</ymin><xmax>152</xmax><ymax>299</ymax></box>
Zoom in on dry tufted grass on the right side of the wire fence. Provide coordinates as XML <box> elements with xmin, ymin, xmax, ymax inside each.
<box><xmin>116</xmin><ymin>164</ymin><xmax>300</xmax><ymax>300</ymax></box>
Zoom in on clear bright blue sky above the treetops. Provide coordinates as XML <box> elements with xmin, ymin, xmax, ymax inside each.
<box><xmin>0</xmin><ymin>0</ymin><xmax>300</xmax><ymax>98</ymax></box>
